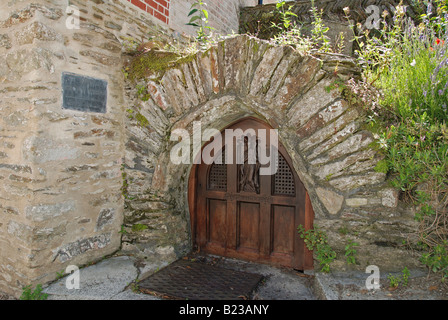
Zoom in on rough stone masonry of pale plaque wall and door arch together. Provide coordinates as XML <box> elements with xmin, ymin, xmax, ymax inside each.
<box><xmin>0</xmin><ymin>0</ymin><xmax>420</xmax><ymax>295</ymax></box>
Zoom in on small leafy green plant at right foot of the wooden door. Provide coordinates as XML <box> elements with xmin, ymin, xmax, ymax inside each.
<box><xmin>297</xmin><ymin>225</ymin><xmax>336</xmax><ymax>273</ymax></box>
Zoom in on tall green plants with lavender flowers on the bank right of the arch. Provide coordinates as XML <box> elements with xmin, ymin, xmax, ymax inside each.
<box><xmin>346</xmin><ymin>0</ymin><xmax>448</xmax><ymax>279</ymax></box>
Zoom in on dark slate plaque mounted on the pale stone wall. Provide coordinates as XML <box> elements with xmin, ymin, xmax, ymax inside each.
<box><xmin>62</xmin><ymin>72</ymin><xmax>107</xmax><ymax>113</ymax></box>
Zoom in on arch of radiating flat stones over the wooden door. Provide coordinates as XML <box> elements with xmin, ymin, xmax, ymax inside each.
<box><xmin>121</xmin><ymin>35</ymin><xmax>396</xmax><ymax>270</ymax></box>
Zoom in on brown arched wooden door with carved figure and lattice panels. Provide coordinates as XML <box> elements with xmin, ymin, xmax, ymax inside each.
<box><xmin>189</xmin><ymin>118</ymin><xmax>314</xmax><ymax>270</ymax></box>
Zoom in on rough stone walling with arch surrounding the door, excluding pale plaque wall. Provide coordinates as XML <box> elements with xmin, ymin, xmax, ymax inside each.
<box><xmin>123</xmin><ymin>36</ymin><xmax>424</xmax><ymax>276</ymax></box>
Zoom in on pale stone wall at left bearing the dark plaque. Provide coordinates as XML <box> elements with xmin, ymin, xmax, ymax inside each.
<box><xmin>0</xmin><ymin>0</ymin><xmax>175</xmax><ymax>295</ymax></box>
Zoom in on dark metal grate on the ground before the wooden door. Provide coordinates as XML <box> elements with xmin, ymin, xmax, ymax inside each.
<box><xmin>139</xmin><ymin>260</ymin><xmax>263</xmax><ymax>300</ymax></box>
